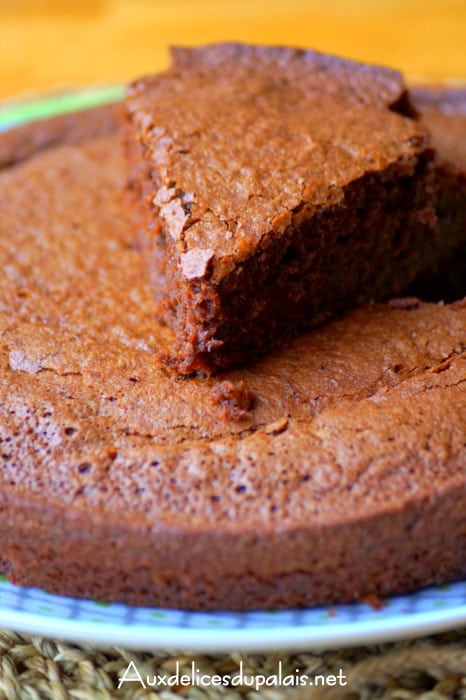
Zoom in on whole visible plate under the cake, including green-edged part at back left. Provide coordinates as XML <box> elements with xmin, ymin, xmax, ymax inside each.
<box><xmin>0</xmin><ymin>86</ymin><xmax>466</xmax><ymax>652</ymax></box>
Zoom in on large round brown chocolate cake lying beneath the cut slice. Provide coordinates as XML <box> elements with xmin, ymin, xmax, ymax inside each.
<box><xmin>0</xmin><ymin>91</ymin><xmax>466</xmax><ymax>610</ymax></box>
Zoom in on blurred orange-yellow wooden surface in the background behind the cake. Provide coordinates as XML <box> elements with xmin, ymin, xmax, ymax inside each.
<box><xmin>0</xmin><ymin>0</ymin><xmax>466</xmax><ymax>99</ymax></box>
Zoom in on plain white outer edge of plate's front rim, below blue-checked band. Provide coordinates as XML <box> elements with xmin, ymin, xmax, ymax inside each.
<box><xmin>0</xmin><ymin>604</ymin><xmax>466</xmax><ymax>653</ymax></box>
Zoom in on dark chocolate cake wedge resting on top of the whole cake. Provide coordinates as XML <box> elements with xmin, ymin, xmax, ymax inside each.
<box><xmin>124</xmin><ymin>44</ymin><xmax>462</xmax><ymax>373</ymax></box>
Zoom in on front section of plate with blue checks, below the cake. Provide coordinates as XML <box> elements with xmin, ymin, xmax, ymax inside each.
<box><xmin>0</xmin><ymin>576</ymin><xmax>466</xmax><ymax>649</ymax></box>
